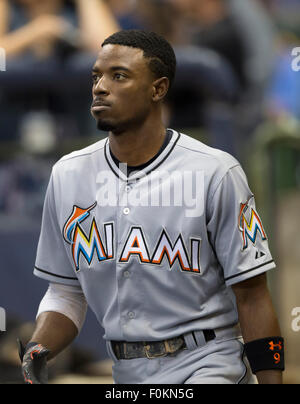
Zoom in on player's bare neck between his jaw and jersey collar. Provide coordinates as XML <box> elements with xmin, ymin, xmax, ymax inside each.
<box><xmin>109</xmin><ymin>122</ymin><xmax>166</xmax><ymax>166</ymax></box>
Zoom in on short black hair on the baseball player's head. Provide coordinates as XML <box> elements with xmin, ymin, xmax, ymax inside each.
<box><xmin>102</xmin><ymin>29</ymin><xmax>176</xmax><ymax>87</ymax></box>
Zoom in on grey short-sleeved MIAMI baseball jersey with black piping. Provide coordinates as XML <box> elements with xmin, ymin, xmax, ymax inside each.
<box><xmin>34</xmin><ymin>131</ymin><xmax>275</xmax><ymax>341</ymax></box>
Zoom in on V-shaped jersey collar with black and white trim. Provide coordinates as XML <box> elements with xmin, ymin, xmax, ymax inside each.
<box><xmin>104</xmin><ymin>129</ymin><xmax>180</xmax><ymax>181</ymax></box>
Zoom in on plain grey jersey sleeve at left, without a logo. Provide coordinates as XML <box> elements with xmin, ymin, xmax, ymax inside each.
<box><xmin>34</xmin><ymin>169</ymin><xmax>79</xmax><ymax>286</ymax></box>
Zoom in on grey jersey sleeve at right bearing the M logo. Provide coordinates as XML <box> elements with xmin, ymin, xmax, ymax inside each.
<box><xmin>208</xmin><ymin>166</ymin><xmax>275</xmax><ymax>286</ymax></box>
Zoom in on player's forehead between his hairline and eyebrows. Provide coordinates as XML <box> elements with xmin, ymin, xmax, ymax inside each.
<box><xmin>93</xmin><ymin>44</ymin><xmax>148</xmax><ymax>72</ymax></box>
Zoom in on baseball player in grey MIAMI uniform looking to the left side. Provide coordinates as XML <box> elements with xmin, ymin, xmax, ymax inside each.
<box><xmin>20</xmin><ymin>30</ymin><xmax>284</xmax><ymax>384</ymax></box>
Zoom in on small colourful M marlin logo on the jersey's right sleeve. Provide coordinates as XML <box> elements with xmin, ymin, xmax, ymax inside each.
<box><xmin>239</xmin><ymin>200</ymin><xmax>267</xmax><ymax>251</ymax></box>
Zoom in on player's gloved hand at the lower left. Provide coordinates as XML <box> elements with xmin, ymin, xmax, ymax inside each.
<box><xmin>18</xmin><ymin>340</ymin><xmax>50</xmax><ymax>384</ymax></box>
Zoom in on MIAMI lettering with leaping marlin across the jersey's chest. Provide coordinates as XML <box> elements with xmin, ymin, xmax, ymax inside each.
<box><xmin>63</xmin><ymin>202</ymin><xmax>201</xmax><ymax>274</ymax></box>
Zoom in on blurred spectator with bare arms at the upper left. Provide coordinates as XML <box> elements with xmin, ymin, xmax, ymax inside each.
<box><xmin>0</xmin><ymin>0</ymin><xmax>119</xmax><ymax>59</ymax></box>
